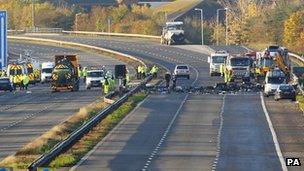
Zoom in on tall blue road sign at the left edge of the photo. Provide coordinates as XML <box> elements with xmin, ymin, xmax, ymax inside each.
<box><xmin>0</xmin><ymin>11</ymin><xmax>7</xmax><ymax>70</ymax></box>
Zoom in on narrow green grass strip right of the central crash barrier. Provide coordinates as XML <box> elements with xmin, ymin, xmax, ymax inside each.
<box><xmin>50</xmin><ymin>92</ymin><xmax>147</xmax><ymax>168</ymax></box>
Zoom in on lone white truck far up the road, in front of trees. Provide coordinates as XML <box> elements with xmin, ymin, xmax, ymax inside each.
<box><xmin>161</xmin><ymin>21</ymin><xmax>185</xmax><ymax>45</ymax></box>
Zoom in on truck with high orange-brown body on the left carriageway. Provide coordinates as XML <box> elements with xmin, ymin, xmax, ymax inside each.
<box><xmin>51</xmin><ymin>55</ymin><xmax>79</xmax><ymax>92</ymax></box>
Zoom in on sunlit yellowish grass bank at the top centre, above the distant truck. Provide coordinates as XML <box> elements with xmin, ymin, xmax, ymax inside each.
<box><xmin>154</xmin><ymin>0</ymin><xmax>202</xmax><ymax>14</ymax></box>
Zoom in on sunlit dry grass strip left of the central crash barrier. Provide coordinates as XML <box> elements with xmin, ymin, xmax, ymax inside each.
<box><xmin>0</xmin><ymin>99</ymin><xmax>109</xmax><ymax>169</ymax></box>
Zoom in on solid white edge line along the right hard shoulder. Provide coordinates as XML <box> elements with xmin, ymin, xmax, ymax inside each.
<box><xmin>260</xmin><ymin>93</ymin><xmax>288</xmax><ymax>171</ymax></box>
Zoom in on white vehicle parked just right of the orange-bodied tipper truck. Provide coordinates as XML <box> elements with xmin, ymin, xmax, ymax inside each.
<box><xmin>86</xmin><ymin>70</ymin><xmax>105</xmax><ymax>89</ymax></box>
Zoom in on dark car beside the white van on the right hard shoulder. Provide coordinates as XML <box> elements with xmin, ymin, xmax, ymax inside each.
<box><xmin>274</xmin><ymin>84</ymin><xmax>296</xmax><ymax>101</ymax></box>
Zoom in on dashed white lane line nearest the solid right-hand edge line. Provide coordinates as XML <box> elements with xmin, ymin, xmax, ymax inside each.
<box><xmin>212</xmin><ymin>94</ymin><xmax>226</xmax><ymax>171</ymax></box>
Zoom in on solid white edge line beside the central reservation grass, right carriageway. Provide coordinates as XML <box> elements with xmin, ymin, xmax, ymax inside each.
<box><xmin>69</xmin><ymin>96</ymin><xmax>149</xmax><ymax>171</ymax></box>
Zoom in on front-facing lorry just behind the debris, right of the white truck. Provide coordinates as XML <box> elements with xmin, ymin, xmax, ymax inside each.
<box><xmin>224</xmin><ymin>55</ymin><xmax>251</xmax><ymax>83</ymax></box>
